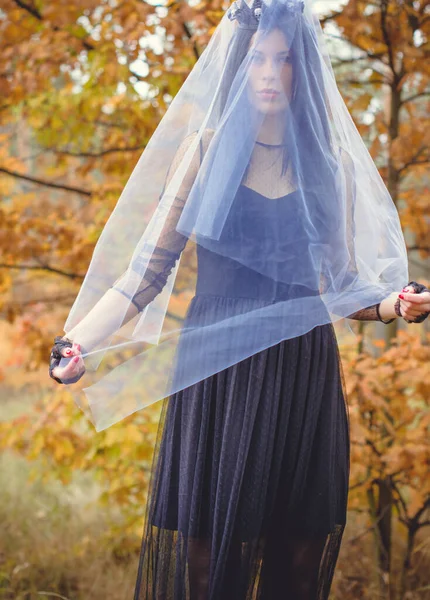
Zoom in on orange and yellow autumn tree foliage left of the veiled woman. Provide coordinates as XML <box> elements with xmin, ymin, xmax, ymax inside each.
<box><xmin>0</xmin><ymin>0</ymin><xmax>222</xmax><ymax>556</ymax></box>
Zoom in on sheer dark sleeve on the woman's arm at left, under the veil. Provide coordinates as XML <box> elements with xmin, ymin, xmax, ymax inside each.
<box><xmin>111</xmin><ymin>133</ymin><xmax>207</xmax><ymax>312</ymax></box>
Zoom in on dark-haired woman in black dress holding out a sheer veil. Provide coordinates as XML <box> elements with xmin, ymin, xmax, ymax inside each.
<box><xmin>50</xmin><ymin>0</ymin><xmax>430</xmax><ymax>600</ymax></box>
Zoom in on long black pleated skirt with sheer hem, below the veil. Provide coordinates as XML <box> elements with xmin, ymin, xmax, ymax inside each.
<box><xmin>134</xmin><ymin>296</ymin><xmax>349</xmax><ymax>600</ymax></box>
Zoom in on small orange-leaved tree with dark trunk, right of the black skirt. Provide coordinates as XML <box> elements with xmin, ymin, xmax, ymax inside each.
<box><xmin>343</xmin><ymin>331</ymin><xmax>430</xmax><ymax>600</ymax></box>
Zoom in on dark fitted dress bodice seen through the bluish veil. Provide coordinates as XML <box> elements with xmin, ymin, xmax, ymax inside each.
<box><xmin>196</xmin><ymin>185</ymin><xmax>319</xmax><ymax>301</ymax></box>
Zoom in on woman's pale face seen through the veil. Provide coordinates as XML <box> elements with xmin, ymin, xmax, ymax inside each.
<box><xmin>248</xmin><ymin>29</ymin><xmax>293</xmax><ymax>115</ymax></box>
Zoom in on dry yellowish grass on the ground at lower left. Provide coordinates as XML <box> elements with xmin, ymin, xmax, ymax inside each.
<box><xmin>0</xmin><ymin>453</ymin><xmax>141</xmax><ymax>600</ymax></box>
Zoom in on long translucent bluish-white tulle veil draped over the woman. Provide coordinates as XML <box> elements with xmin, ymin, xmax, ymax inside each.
<box><xmin>60</xmin><ymin>0</ymin><xmax>408</xmax><ymax>431</ymax></box>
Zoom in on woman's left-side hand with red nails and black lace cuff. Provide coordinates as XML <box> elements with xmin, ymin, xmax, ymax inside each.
<box><xmin>49</xmin><ymin>336</ymin><xmax>85</xmax><ymax>384</ymax></box>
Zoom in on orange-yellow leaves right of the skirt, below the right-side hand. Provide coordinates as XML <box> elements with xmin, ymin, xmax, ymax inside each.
<box><xmin>343</xmin><ymin>331</ymin><xmax>430</xmax><ymax>517</ymax></box>
